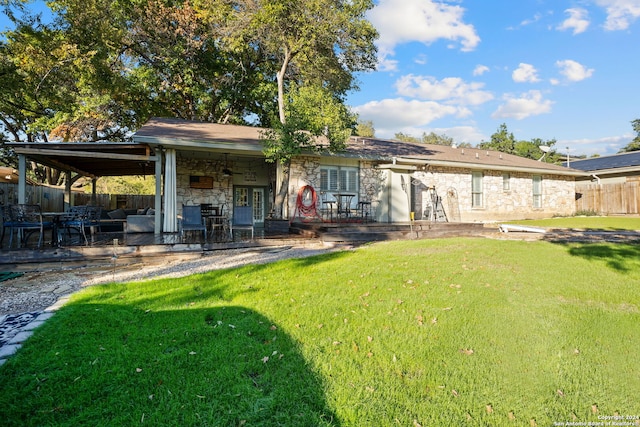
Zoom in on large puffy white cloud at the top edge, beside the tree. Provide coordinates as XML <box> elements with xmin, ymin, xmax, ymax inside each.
<box><xmin>368</xmin><ymin>0</ymin><xmax>480</xmax><ymax>61</ymax></box>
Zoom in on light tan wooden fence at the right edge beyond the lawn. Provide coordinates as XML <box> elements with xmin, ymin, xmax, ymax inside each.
<box><xmin>576</xmin><ymin>181</ymin><xmax>640</xmax><ymax>215</ymax></box>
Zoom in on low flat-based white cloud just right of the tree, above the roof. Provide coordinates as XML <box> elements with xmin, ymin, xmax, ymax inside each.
<box><xmin>353</xmin><ymin>98</ymin><xmax>470</xmax><ymax>135</ymax></box>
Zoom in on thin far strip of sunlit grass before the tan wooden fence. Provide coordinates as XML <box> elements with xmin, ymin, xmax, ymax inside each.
<box><xmin>507</xmin><ymin>216</ymin><xmax>640</xmax><ymax>231</ymax></box>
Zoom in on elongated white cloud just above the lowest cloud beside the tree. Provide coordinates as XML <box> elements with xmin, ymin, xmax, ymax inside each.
<box><xmin>395</xmin><ymin>74</ymin><xmax>493</xmax><ymax>105</ymax></box>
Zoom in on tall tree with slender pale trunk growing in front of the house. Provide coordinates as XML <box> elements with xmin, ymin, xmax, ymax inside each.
<box><xmin>210</xmin><ymin>0</ymin><xmax>377</xmax><ymax>217</ymax></box>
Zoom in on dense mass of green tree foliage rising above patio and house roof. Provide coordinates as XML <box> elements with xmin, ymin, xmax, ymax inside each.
<box><xmin>0</xmin><ymin>0</ymin><xmax>377</xmax><ymax>207</ymax></box>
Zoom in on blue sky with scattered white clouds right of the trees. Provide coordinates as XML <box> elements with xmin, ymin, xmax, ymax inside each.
<box><xmin>348</xmin><ymin>0</ymin><xmax>640</xmax><ymax>155</ymax></box>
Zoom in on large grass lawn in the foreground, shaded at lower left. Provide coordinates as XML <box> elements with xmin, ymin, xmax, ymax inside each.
<box><xmin>0</xmin><ymin>239</ymin><xmax>640</xmax><ymax>427</ymax></box>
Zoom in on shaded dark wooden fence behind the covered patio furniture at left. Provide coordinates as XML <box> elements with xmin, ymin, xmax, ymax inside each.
<box><xmin>0</xmin><ymin>183</ymin><xmax>155</xmax><ymax>212</ymax></box>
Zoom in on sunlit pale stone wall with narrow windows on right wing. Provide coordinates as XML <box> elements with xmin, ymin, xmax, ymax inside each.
<box><xmin>414</xmin><ymin>167</ymin><xmax>575</xmax><ymax>222</ymax></box>
